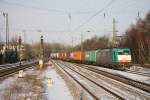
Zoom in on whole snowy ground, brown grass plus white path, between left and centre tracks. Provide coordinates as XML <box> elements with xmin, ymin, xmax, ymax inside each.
<box><xmin>0</xmin><ymin>64</ymin><xmax>73</xmax><ymax>100</ymax></box>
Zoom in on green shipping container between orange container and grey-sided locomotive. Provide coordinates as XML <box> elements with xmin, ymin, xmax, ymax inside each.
<box><xmin>85</xmin><ymin>50</ymin><xmax>99</xmax><ymax>62</ymax></box>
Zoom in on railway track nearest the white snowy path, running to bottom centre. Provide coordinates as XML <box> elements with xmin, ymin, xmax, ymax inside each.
<box><xmin>52</xmin><ymin>59</ymin><xmax>124</xmax><ymax>100</ymax></box>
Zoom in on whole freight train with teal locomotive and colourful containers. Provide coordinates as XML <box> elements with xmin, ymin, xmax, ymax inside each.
<box><xmin>50</xmin><ymin>48</ymin><xmax>131</xmax><ymax>66</ymax></box>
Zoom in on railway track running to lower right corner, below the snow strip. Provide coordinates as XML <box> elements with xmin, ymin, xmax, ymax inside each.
<box><xmin>53</xmin><ymin>61</ymin><xmax>150</xmax><ymax>100</ymax></box>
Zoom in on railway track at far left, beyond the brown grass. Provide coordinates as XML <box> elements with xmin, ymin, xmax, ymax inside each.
<box><xmin>0</xmin><ymin>61</ymin><xmax>38</xmax><ymax>79</ymax></box>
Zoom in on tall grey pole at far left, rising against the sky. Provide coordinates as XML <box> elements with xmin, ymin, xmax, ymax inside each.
<box><xmin>3</xmin><ymin>13</ymin><xmax>9</xmax><ymax>49</ymax></box>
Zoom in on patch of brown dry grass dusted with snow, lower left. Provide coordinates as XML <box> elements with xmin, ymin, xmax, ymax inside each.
<box><xmin>0</xmin><ymin>67</ymin><xmax>44</xmax><ymax>100</ymax></box>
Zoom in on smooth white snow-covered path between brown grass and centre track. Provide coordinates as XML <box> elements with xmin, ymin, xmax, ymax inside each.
<box><xmin>43</xmin><ymin>62</ymin><xmax>73</xmax><ymax>100</ymax></box>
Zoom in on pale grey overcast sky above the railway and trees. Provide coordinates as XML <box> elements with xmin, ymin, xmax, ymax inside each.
<box><xmin>0</xmin><ymin>0</ymin><xmax>150</xmax><ymax>44</ymax></box>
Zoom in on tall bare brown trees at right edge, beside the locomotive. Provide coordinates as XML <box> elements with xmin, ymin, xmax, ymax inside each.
<box><xmin>125</xmin><ymin>12</ymin><xmax>150</xmax><ymax>63</ymax></box>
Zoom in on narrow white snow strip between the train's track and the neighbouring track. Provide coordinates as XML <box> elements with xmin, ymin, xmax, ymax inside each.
<box><xmin>88</xmin><ymin>66</ymin><xmax>150</xmax><ymax>84</ymax></box>
